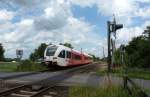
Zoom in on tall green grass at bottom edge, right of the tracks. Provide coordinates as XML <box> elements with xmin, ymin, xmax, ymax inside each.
<box><xmin>69</xmin><ymin>85</ymin><xmax>136</xmax><ymax>97</ymax></box>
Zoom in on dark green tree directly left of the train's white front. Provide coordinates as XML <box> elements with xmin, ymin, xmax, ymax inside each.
<box><xmin>30</xmin><ymin>43</ymin><xmax>47</xmax><ymax>61</ymax></box>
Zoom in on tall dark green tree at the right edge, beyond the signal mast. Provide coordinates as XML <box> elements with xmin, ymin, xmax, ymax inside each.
<box><xmin>126</xmin><ymin>27</ymin><xmax>150</xmax><ymax>68</ymax></box>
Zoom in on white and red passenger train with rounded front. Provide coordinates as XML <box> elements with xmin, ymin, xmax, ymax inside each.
<box><xmin>44</xmin><ymin>44</ymin><xmax>92</xmax><ymax>67</ymax></box>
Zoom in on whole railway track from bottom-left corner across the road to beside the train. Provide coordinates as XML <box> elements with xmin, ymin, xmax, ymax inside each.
<box><xmin>0</xmin><ymin>65</ymin><xmax>95</xmax><ymax>97</ymax></box>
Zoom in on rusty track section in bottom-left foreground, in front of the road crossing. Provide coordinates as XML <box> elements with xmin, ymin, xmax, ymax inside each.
<box><xmin>0</xmin><ymin>85</ymin><xmax>53</xmax><ymax>97</ymax></box>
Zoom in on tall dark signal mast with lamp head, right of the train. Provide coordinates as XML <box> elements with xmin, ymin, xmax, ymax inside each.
<box><xmin>107</xmin><ymin>17</ymin><xmax>123</xmax><ymax>73</ymax></box>
